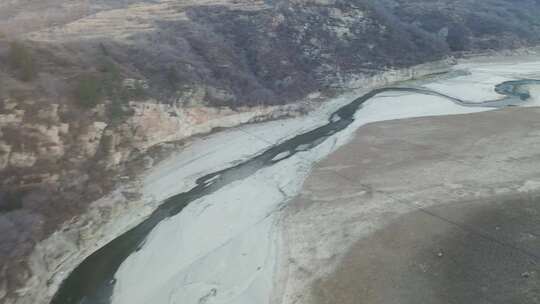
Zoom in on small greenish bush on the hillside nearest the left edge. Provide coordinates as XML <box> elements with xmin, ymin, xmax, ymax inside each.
<box><xmin>7</xmin><ymin>41</ymin><xmax>37</xmax><ymax>81</ymax></box>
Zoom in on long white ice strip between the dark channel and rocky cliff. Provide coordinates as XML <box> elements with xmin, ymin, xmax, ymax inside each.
<box><xmin>143</xmin><ymin>93</ymin><xmax>354</xmax><ymax>201</ymax></box>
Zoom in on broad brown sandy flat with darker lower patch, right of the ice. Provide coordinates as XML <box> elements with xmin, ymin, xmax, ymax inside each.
<box><xmin>281</xmin><ymin>108</ymin><xmax>540</xmax><ymax>304</ymax></box>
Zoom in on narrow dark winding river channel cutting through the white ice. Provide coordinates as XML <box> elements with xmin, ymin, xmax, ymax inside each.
<box><xmin>51</xmin><ymin>80</ymin><xmax>540</xmax><ymax>304</ymax></box>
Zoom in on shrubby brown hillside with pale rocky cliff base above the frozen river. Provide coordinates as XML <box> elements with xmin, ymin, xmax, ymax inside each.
<box><xmin>0</xmin><ymin>0</ymin><xmax>540</xmax><ymax>303</ymax></box>
